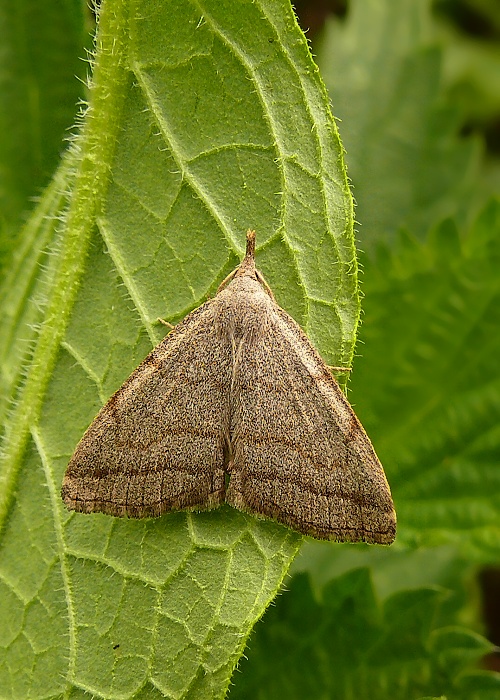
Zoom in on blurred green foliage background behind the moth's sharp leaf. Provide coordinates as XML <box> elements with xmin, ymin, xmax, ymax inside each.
<box><xmin>0</xmin><ymin>0</ymin><xmax>500</xmax><ymax>699</ymax></box>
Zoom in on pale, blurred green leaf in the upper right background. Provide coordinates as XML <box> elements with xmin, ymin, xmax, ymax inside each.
<box><xmin>317</xmin><ymin>0</ymin><xmax>486</xmax><ymax>252</ymax></box>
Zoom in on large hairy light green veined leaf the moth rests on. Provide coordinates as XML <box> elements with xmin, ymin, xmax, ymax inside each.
<box><xmin>0</xmin><ymin>0</ymin><xmax>359</xmax><ymax>700</ymax></box>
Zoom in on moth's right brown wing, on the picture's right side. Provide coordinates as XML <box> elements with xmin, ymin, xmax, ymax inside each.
<box><xmin>226</xmin><ymin>302</ymin><xmax>396</xmax><ymax>544</ymax></box>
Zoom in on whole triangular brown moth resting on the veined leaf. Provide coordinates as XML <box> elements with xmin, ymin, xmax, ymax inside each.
<box><xmin>62</xmin><ymin>231</ymin><xmax>396</xmax><ymax>544</ymax></box>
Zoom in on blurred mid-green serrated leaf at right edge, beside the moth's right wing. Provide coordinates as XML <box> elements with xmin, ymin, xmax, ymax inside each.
<box><xmin>352</xmin><ymin>202</ymin><xmax>500</xmax><ymax>561</ymax></box>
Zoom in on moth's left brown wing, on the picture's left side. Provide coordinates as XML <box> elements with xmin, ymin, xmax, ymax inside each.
<box><xmin>62</xmin><ymin>301</ymin><xmax>231</xmax><ymax>518</ymax></box>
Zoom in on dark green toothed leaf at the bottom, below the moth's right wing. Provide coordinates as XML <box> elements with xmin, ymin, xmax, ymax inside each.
<box><xmin>230</xmin><ymin>569</ymin><xmax>500</xmax><ymax>700</ymax></box>
